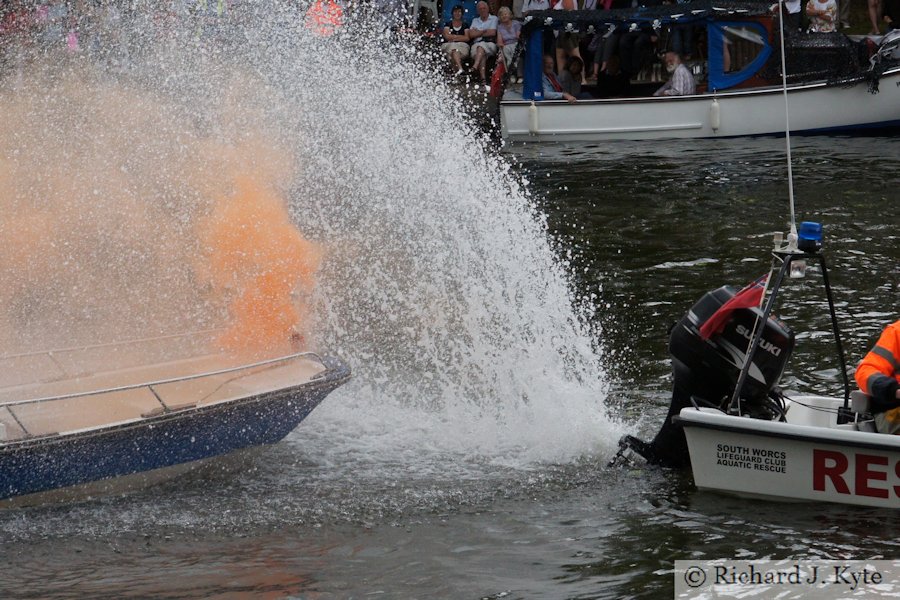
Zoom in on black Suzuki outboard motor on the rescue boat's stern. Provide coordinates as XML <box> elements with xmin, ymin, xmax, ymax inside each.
<box><xmin>619</xmin><ymin>286</ymin><xmax>794</xmax><ymax>467</ymax></box>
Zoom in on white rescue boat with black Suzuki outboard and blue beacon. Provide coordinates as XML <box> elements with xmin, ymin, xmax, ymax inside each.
<box><xmin>613</xmin><ymin>223</ymin><xmax>900</xmax><ymax>508</ymax></box>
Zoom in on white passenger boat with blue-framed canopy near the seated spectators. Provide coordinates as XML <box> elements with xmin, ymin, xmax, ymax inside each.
<box><xmin>500</xmin><ymin>0</ymin><xmax>900</xmax><ymax>142</ymax></box>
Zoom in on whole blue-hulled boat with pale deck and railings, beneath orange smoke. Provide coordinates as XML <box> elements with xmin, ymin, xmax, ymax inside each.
<box><xmin>0</xmin><ymin>334</ymin><xmax>350</xmax><ymax>508</ymax></box>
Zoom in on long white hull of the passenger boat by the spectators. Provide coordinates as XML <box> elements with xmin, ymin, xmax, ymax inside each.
<box><xmin>500</xmin><ymin>68</ymin><xmax>900</xmax><ymax>142</ymax></box>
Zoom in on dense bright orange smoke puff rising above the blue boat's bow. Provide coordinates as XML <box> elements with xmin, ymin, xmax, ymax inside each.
<box><xmin>199</xmin><ymin>174</ymin><xmax>321</xmax><ymax>354</ymax></box>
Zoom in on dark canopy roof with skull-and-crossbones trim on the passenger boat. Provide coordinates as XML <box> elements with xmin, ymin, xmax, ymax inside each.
<box><xmin>524</xmin><ymin>0</ymin><xmax>775</xmax><ymax>32</ymax></box>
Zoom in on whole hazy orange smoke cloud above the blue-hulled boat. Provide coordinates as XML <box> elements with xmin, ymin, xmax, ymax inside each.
<box><xmin>0</xmin><ymin>61</ymin><xmax>320</xmax><ymax>355</ymax></box>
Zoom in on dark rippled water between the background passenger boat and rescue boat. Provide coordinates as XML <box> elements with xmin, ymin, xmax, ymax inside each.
<box><xmin>516</xmin><ymin>137</ymin><xmax>900</xmax><ymax>404</ymax></box>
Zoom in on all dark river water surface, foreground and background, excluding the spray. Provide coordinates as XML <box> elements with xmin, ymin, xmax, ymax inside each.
<box><xmin>0</xmin><ymin>137</ymin><xmax>900</xmax><ymax>599</ymax></box>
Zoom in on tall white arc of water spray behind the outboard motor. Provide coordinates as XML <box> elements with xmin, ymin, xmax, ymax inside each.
<box><xmin>0</xmin><ymin>2</ymin><xmax>620</xmax><ymax>473</ymax></box>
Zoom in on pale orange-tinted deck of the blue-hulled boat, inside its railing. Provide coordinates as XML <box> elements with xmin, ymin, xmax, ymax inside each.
<box><xmin>0</xmin><ymin>332</ymin><xmax>326</xmax><ymax>443</ymax></box>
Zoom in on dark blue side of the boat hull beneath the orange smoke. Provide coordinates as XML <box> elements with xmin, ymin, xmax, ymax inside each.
<box><xmin>0</xmin><ymin>358</ymin><xmax>350</xmax><ymax>500</ymax></box>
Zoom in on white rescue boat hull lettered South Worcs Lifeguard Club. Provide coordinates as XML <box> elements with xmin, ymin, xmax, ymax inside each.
<box><xmin>677</xmin><ymin>396</ymin><xmax>900</xmax><ymax>508</ymax></box>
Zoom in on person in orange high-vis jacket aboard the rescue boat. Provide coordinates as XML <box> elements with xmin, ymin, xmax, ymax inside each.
<box><xmin>856</xmin><ymin>321</ymin><xmax>900</xmax><ymax>434</ymax></box>
